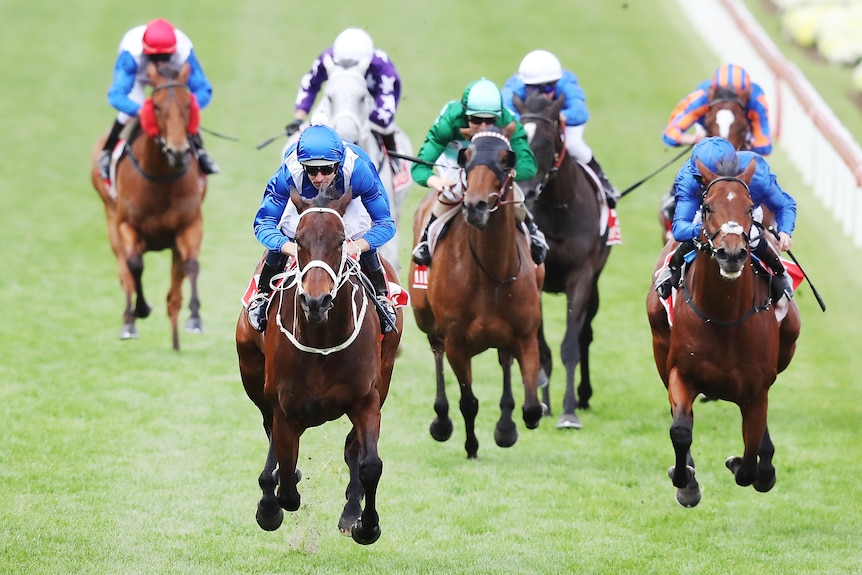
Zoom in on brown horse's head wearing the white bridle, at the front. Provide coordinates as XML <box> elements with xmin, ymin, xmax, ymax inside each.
<box><xmin>290</xmin><ymin>189</ymin><xmax>353</xmax><ymax>324</ymax></box>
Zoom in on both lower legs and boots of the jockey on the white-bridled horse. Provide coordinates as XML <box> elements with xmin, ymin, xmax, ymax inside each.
<box><xmin>248</xmin><ymin>250</ymin><xmax>396</xmax><ymax>335</ymax></box>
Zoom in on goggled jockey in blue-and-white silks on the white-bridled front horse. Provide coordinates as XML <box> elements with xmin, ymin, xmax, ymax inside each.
<box><xmin>248</xmin><ymin>115</ymin><xmax>395</xmax><ymax>333</ymax></box>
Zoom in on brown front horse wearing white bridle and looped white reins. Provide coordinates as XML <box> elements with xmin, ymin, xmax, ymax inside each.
<box><xmin>236</xmin><ymin>190</ymin><xmax>404</xmax><ymax>545</ymax></box>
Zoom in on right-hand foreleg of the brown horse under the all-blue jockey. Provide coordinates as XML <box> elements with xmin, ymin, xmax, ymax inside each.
<box><xmin>725</xmin><ymin>391</ymin><xmax>775</xmax><ymax>491</ymax></box>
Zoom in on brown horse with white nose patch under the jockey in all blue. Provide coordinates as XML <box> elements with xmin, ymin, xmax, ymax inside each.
<box><xmin>646</xmin><ymin>155</ymin><xmax>801</xmax><ymax>507</ymax></box>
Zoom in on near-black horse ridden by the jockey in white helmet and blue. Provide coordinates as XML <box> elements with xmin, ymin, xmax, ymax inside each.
<box><xmin>514</xmin><ymin>93</ymin><xmax>611</xmax><ymax>429</ymax></box>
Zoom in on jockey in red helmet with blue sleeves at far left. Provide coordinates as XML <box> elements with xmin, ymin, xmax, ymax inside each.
<box><xmin>98</xmin><ymin>18</ymin><xmax>219</xmax><ymax>180</ymax></box>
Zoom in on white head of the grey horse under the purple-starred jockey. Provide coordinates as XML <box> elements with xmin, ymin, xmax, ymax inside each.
<box><xmin>323</xmin><ymin>66</ymin><xmax>373</xmax><ymax>145</ymax></box>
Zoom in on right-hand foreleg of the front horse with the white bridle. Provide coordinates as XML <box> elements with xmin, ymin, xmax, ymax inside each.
<box><xmin>350</xmin><ymin>394</ymin><xmax>383</xmax><ymax>545</ymax></box>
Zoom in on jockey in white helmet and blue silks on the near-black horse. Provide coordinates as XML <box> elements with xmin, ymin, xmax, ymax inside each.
<box><xmin>502</xmin><ymin>50</ymin><xmax>620</xmax><ymax>207</ymax></box>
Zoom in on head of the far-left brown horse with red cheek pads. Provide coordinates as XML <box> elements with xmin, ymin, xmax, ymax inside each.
<box><xmin>145</xmin><ymin>62</ymin><xmax>200</xmax><ymax>168</ymax></box>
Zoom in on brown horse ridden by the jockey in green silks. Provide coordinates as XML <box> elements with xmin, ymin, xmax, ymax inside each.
<box><xmin>410</xmin><ymin>122</ymin><xmax>544</xmax><ymax>459</ymax></box>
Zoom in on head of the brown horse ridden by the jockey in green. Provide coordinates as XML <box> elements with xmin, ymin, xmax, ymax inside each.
<box><xmin>458</xmin><ymin>122</ymin><xmax>515</xmax><ymax>229</ymax></box>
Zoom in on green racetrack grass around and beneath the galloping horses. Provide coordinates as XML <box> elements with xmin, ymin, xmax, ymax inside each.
<box><xmin>0</xmin><ymin>0</ymin><xmax>862</xmax><ymax>575</ymax></box>
